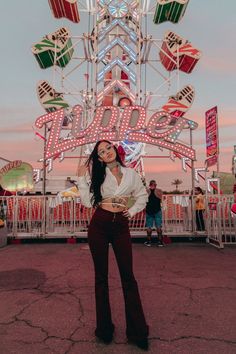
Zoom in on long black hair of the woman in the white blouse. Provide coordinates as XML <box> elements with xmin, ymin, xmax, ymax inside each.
<box><xmin>86</xmin><ymin>140</ymin><xmax>124</xmax><ymax>207</ymax></box>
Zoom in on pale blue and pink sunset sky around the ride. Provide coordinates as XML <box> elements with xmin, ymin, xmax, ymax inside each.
<box><xmin>0</xmin><ymin>0</ymin><xmax>236</xmax><ymax>190</ymax></box>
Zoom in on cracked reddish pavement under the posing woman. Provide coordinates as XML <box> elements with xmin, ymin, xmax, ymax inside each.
<box><xmin>0</xmin><ymin>243</ymin><xmax>236</xmax><ymax>354</ymax></box>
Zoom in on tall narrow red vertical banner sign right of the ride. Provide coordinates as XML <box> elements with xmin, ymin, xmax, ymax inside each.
<box><xmin>205</xmin><ymin>107</ymin><xmax>219</xmax><ymax>167</ymax></box>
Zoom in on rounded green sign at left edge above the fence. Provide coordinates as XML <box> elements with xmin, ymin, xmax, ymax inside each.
<box><xmin>0</xmin><ymin>160</ymin><xmax>34</xmax><ymax>192</ymax></box>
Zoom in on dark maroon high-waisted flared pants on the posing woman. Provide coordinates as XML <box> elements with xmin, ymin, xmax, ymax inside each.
<box><xmin>88</xmin><ymin>208</ymin><xmax>148</xmax><ymax>340</ymax></box>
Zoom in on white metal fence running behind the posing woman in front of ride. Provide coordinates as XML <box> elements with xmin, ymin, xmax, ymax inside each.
<box><xmin>0</xmin><ymin>194</ymin><xmax>236</xmax><ymax>247</ymax></box>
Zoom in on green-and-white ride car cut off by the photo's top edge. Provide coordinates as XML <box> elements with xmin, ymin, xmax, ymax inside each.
<box><xmin>153</xmin><ymin>0</ymin><xmax>189</xmax><ymax>24</ymax></box>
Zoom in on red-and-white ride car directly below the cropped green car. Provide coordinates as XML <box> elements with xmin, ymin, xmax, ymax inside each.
<box><xmin>159</xmin><ymin>31</ymin><xmax>201</xmax><ymax>74</ymax></box>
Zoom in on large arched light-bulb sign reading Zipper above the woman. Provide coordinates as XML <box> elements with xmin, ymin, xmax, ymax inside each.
<box><xmin>35</xmin><ymin>105</ymin><xmax>198</xmax><ymax>160</ymax></box>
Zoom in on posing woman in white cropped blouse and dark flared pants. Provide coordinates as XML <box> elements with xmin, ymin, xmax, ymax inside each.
<box><xmin>78</xmin><ymin>140</ymin><xmax>148</xmax><ymax>350</ymax></box>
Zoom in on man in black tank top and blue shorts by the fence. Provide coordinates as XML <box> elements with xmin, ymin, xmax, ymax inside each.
<box><xmin>144</xmin><ymin>180</ymin><xmax>164</xmax><ymax>247</ymax></box>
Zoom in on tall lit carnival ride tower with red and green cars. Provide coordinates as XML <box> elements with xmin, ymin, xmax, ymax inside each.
<box><xmin>32</xmin><ymin>0</ymin><xmax>201</xmax><ymax>183</ymax></box>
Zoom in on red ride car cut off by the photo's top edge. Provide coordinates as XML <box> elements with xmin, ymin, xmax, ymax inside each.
<box><xmin>48</xmin><ymin>0</ymin><xmax>80</xmax><ymax>23</ymax></box>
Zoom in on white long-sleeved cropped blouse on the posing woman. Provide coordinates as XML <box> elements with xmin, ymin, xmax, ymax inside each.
<box><xmin>78</xmin><ymin>166</ymin><xmax>148</xmax><ymax>217</ymax></box>
